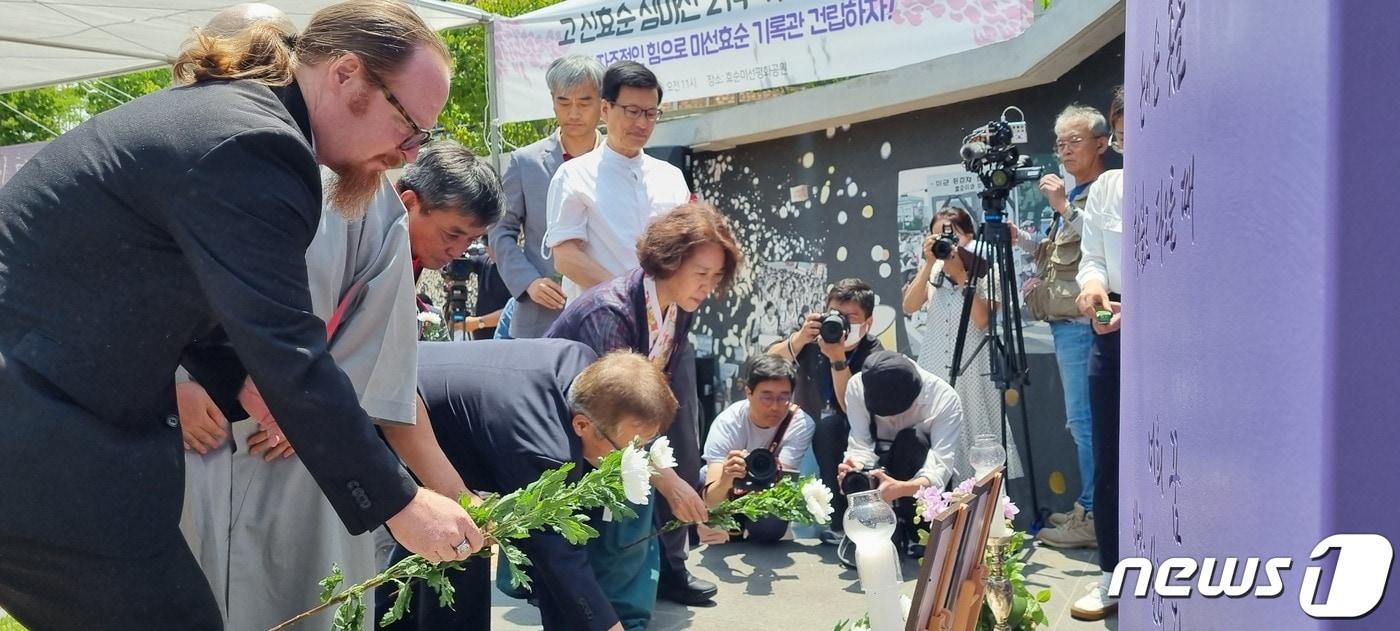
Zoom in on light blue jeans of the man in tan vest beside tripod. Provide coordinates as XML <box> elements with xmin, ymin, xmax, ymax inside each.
<box><xmin>1050</xmin><ymin>320</ymin><xmax>1093</xmax><ymax>512</ymax></box>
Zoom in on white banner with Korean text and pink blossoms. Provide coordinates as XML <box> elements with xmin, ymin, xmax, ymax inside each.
<box><xmin>493</xmin><ymin>0</ymin><xmax>1033</xmax><ymax>122</ymax></box>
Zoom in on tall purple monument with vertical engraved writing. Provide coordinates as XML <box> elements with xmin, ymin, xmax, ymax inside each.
<box><xmin>1119</xmin><ymin>0</ymin><xmax>1400</xmax><ymax>631</ymax></box>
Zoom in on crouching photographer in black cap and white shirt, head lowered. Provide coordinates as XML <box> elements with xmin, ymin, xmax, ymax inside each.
<box><xmin>836</xmin><ymin>351</ymin><xmax>963</xmax><ymax>567</ymax></box>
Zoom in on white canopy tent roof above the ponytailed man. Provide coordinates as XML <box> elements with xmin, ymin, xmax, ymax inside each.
<box><xmin>0</xmin><ymin>0</ymin><xmax>494</xmax><ymax>92</ymax></box>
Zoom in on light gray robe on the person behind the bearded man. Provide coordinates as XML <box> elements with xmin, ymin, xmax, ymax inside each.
<box><xmin>181</xmin><ymin>172</ymin><xmax>417</xmax><ymax>631</ymax></box>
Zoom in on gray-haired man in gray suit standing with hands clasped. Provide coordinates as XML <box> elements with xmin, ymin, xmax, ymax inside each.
<box><xmin>491</xmin><ymin>55</ymin><xmax>603</xmax><ymax>337</ymax></box>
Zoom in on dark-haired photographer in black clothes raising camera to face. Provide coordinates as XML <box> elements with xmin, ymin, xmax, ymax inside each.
<box><xmin>769</xmin><ymin>278</ymin><xmax>885</xmax><ymax>546</ymax></box>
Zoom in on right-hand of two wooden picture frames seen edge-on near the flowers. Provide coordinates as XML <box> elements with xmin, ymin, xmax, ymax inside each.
<box><xmin>944</xmin><ymin>466</ymin><xmax>1005</xmax><ymax>631</ymax></box>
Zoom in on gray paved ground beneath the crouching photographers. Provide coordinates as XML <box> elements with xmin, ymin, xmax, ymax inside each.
<box><xmin>491</xmin><ymin>537</ymin><xmax>1117</xmax><ymax>631</ymax></box>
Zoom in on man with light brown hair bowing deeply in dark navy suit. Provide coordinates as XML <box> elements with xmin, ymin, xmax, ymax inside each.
<box><xmin>372</xmin><ymin>340</ymin><xmax>678</xmax><ymax>631</ymax></box>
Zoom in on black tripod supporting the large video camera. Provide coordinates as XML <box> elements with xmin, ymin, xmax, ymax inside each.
<box><xmin>948</xmin><ymin>187</ymin><xmax>1040</xmax><ymax>520</ymax></box>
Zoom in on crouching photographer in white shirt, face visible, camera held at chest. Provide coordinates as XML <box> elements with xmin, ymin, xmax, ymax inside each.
<box><xmin>700</xmin><ymin>355</ymin><xmax>815</xmax><ymax>543</ymax></box>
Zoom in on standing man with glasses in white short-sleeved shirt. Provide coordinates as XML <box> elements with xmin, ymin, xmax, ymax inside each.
<box><xmin>545</xmin><ymin>62</ymin><xmax>690</xmax><ymax>298</ymax></box>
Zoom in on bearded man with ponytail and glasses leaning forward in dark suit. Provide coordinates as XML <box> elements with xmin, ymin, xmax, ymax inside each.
<box><xmin>0</xmin><ymin>0</ymin><xmax>480</xmax><ymax>631</ymax></box>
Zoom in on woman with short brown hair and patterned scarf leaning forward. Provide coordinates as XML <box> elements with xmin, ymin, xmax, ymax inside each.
<box><xmin>545</xmin><ymin>203</ymin><xmax>743</xmax><ymax>621</ymax></box>
